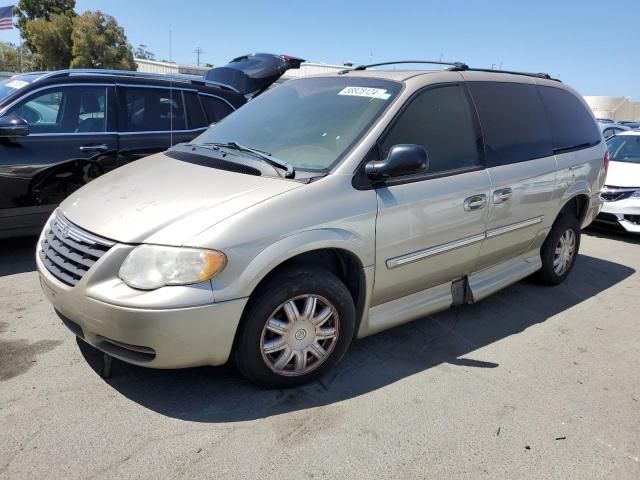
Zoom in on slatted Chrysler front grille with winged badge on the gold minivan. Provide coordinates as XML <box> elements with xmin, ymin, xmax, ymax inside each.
<box><xmin>39</xmin><ymin>213</ymin><xmax>114</xmax><ymax>286</ymax></box>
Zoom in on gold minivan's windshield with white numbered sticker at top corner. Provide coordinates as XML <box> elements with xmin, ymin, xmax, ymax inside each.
<box><xmin>192</xmin><ymin>75</ymin><xmax>401</xmax><ymax>171</ymax></box>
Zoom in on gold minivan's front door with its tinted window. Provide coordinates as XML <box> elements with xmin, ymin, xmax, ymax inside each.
<box><xmin>372</xmin><ymin>84</ymin><xmax>491</xmax><ymax>306</ymax></box>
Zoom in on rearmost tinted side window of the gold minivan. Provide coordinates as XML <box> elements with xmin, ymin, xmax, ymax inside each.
<box><xmin>538</xmin><ymin>87</ymin><xmax>600</xmax><ymax>151</ymax></box>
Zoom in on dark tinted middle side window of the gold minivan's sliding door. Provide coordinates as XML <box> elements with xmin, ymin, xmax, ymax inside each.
<box><xmin>468</xmin><ymin>82</ymin><xmax>553</xmax><ymax>167</ymax></box>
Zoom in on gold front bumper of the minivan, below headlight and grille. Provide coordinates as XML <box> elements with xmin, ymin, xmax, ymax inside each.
<box><xmin>36</xmin><ymin>249</ymin><xmax>247</xmax><ymax>368</ymax></box>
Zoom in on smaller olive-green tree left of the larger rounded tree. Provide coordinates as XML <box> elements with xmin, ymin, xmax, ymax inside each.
<box><xmin>24</xmin><ymin>14</ymin><xmax>73</xmax><ymax>70</ymax></box>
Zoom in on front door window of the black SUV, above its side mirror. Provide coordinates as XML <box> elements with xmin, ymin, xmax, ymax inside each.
<box><xmin>8</xmin><ymin>87</ymin><xmax>107</xmax><ymax>133</ymax></box>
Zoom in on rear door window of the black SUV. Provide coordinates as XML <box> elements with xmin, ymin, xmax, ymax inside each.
<box><xmin>120</xmin><ymin>87</ymin><xmax>186</xmax><ymax>132</ymax></box>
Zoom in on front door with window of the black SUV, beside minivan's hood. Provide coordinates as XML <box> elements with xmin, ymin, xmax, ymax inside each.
<box><xmin>0</xmin><ymin>85</ymin><xmax>118</xmax><ymax>234</ymax></box>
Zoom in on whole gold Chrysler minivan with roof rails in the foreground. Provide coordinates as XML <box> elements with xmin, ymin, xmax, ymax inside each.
<box><xmin>37</xmin><ymin>63</ymin><xmax>607</xmax><ymax>386</ymax></box>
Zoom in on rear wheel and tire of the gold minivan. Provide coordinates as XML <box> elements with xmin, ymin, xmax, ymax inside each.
<box><xmin>534</xmin><ymin>215</ymin><xmax>581</xmax><ymax>286</ymax></box>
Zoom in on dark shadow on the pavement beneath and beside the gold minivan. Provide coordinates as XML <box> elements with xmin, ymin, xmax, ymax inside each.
<box><xmin>78</xmin><ymin>255</ymin><xmax>635</xmax><ymax>422</ymax></box>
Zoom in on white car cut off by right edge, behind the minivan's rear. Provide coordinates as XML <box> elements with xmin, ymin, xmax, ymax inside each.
<box><xmin>597</xmin><ymin>130</ymin><xmax>640</xmax><ymax>233</ymax></box>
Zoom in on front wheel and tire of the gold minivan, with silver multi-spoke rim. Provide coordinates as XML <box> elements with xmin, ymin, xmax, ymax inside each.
<box><xmin>234</xmin><ymin>266</ymin><xmax>355</xmax><ymax>387</ymax></box>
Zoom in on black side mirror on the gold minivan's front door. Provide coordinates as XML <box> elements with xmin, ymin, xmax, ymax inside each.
<box><xmin>364</xmin><ymin>144</ymin><xmax>429</xmax><ymax>180</ymax></box>
